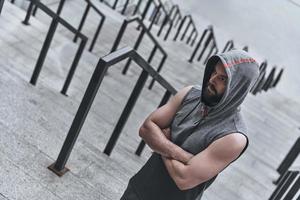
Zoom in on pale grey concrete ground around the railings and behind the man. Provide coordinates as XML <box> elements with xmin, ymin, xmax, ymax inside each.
<box><xmin>0</xmin><ymin>1</ymin><xmax>300</xmax><ymax>200</ymax></box>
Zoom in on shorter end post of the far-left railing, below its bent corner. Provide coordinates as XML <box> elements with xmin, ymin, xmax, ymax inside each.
<box><xmin>61</xmin><ymin>38</ymin><xmax>87</xmax><ymax>95</ymax></box>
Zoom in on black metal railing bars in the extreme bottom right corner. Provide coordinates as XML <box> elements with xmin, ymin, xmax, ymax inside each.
<box><xmin>269</xmin><ymin>167</ymin><xmax>300</xmax><ymax>200</ymax></box>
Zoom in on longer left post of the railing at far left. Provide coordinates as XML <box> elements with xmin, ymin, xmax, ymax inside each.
<box><xmin>30</xmin><ymin>16</ymin><xmax>58</xmax><ymax>85</ymax></box>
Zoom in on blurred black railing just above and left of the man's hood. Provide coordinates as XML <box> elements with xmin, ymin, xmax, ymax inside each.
<box><xmin>188</xmin><ymin>26</ymin><xmax>218</xmax><ymax>63</ymax></box>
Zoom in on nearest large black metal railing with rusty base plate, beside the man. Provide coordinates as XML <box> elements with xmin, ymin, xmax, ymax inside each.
<box><xmin>48</xmin><ymin>47</ymin><xmax>177</xmax><ymax>176</ymax></box>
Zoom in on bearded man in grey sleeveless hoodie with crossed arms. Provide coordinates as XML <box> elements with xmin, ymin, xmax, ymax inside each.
<box><xmin>121</xmin><ymin>50</ymin><xmax>259</xmax><ymax>200</ymax></box>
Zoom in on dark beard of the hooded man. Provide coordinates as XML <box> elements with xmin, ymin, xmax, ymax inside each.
<box><xmin>203</xmin><ymin>83</ymin><xmax>223</xmax><ymax>106</ymax></box>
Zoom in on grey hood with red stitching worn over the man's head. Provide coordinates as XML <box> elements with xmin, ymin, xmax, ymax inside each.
<box><xmin>201</xmin><ymin>50</ymin><xmax>259</xmax><ymax>117</ymax></box>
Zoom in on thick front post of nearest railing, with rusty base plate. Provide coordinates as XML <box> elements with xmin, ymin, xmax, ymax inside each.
<box><xmin>48</xmin><ymin>59</ymin><xmax>108</xmax><ymax>176</ymax></box>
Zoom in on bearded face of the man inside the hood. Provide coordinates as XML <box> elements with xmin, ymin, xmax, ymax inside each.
<box><xmin>203</xmin><ymin>62</ymin><xmax>228</xmax><ymax>106</ymax></box>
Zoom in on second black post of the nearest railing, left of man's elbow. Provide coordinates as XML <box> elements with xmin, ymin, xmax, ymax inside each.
<box><xmin>104</xmin><ymin>70</ymin><xmax>148</xmax><ymax>156</ymax></box>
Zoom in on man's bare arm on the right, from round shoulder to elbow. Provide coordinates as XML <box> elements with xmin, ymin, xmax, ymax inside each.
<box><xmin>163</xmin><ymin>133</ymin><xmax>247</xmax><ymax>190</ymax></box>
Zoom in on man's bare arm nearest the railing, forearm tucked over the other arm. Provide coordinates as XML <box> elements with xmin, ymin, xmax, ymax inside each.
<box><xmin>139</xmin><ymin>86</ymin><xmax>193</xmax><ymax>163</ymax></box>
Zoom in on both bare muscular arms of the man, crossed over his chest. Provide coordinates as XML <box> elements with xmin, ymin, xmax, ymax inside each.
<box><xmin>139</xmin><ymin>86</ymin><xmax>247</xmax><ymax>190</ymax></box>
